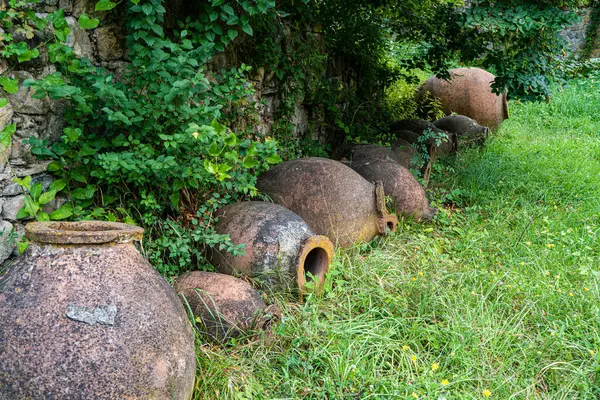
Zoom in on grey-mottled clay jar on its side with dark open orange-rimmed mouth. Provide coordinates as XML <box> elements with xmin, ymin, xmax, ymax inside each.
<box><xmin>207</xmin><ymin>201</ymin><xmax>334</xmax><ymax>292</ymax></box>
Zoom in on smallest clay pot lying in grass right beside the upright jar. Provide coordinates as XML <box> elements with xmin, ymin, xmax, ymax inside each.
<box><xmin>174</xmin><ymin>271</ymin><xmax>279</xmax><ymax>342</ymax></box>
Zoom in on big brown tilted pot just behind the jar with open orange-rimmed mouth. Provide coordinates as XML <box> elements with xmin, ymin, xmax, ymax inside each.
<box><xmin>257</xmin><ymin>157</ymin><xmax>398</xmax><ymax>247</ymax></box>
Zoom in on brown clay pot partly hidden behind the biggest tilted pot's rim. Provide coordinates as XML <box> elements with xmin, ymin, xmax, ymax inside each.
<box><xmin>352</xmin><ymin>159</ymin><xmax>435</xmax><ymax>219</ymax></box>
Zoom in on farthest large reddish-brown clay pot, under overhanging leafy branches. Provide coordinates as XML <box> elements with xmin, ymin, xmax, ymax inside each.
<box><xmin>419</xmin><ymin>68</ymin><xmax>508</xmax><ymax>129</ymax></box>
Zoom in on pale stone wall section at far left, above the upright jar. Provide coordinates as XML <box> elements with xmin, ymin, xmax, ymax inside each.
<box><xmin>0</xmin><ymin>0</ymin><xmax>126</xmax><ymax>263</ymax></box>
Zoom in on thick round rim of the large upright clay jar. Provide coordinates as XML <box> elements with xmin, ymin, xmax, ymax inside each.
<box><xmin>25</xmin><ymin>221</ymin><xmax>144</xmax><ymax>244</ymax></box>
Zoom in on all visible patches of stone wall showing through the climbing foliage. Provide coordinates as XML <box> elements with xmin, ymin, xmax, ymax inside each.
<box><xmin>0</xmin><ymin>0</ymin><xmax>322</xmax><ymax>263</ymax></box>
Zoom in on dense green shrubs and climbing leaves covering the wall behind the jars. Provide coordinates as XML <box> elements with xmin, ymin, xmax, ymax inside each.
<box><xmin>0</xmin><ymin>0</ymin><xmax>592</xmax><ymax>275</ymax></box>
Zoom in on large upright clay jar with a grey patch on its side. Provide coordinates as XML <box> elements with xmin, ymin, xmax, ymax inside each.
<box><xmin>0</xmin><ymin>221</ymin><xmax>196</xmax><ymax>400</ymax></box>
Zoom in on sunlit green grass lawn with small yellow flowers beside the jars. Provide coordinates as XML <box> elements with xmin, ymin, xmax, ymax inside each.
<box><xmin>196</xmin><ymin>80</ymin><xmax>600</xmax><ymax>399</ymax></box>
